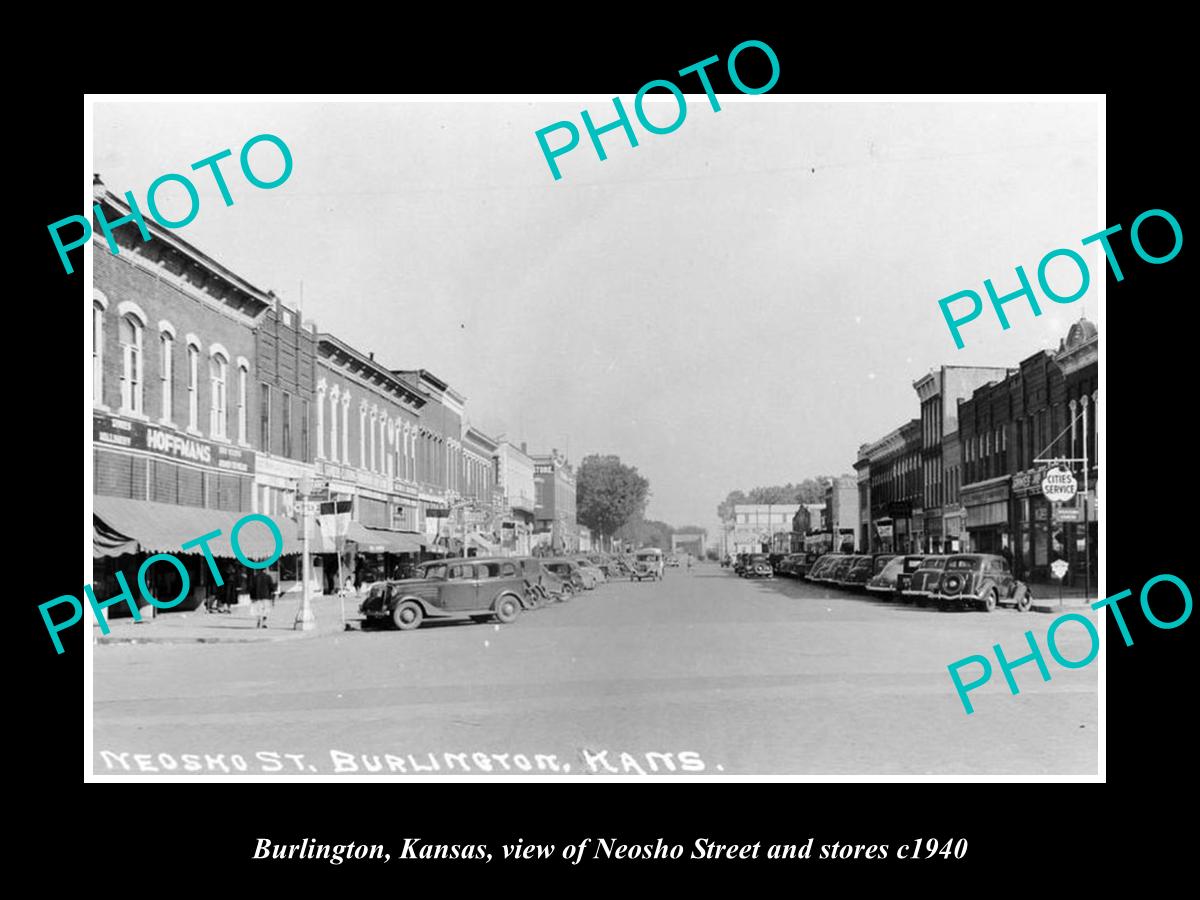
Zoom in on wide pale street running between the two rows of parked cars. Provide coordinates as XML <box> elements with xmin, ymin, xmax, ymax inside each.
<box><xmin>94</xmin><ymin>564</ymin><xmax>1098</xmax><ymax>775</ymax></box>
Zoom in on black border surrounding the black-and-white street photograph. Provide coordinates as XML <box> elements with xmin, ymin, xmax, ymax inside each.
<box><xmin>18</xmin><ymin>19</ymin><xmax>1200</xmax><ymax>890</ymax></box>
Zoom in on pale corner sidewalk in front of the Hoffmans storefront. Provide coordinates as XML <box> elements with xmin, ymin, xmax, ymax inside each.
<box><xmin>92</xmin><ymin>593</ymin><xmax>361</xmax><ymax>643</ymax></box>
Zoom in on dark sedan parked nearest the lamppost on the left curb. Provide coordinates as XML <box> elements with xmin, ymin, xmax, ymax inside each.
<box><xmin>359</xmin><ymin>557</ymin><xmax>526</xmax><ymax>631</ymax></box>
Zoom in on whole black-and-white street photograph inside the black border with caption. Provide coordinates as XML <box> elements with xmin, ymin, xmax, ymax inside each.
<box><xmin>87</xmin><ymin>94</ymin><xmax>1099</xmax><ymax>779</ymax></box>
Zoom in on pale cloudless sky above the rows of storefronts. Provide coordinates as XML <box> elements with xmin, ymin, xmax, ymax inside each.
<box><xmin>94</xmin><ymin>100</ymin><xmax>1111</xmax><ymax>534</ymax></box>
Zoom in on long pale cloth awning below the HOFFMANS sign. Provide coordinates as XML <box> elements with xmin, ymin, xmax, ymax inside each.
<box><xmin>92</xmin><ymin>494</ymin><xmax>288</xmax><ymax>559</ymax></box>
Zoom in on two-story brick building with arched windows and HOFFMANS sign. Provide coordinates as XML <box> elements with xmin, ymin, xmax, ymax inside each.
<box><xmin>91</xmin><ymin>180</ymin><xmax>278</xmax><ymax>611</ymax></box>
